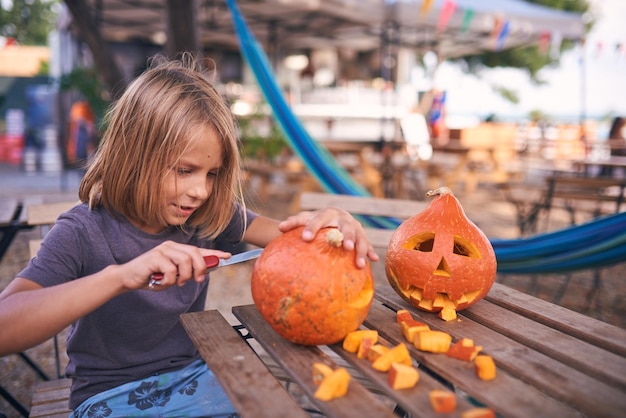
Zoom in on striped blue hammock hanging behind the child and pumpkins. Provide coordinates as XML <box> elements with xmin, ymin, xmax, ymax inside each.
<box><xmin>227</xmin><ymin>0</ymin><xmax>626</xmax><ymax>274</ymax></box>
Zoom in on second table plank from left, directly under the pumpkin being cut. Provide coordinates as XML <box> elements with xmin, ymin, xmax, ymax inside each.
<box><xmin>233</xmin><ymin>305</ymin><xmax>395</xmax><ymax>418</ymax></box>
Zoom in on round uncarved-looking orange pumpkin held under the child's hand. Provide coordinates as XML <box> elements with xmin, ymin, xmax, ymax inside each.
<box><xmin>252</xmin><ymin>227</ymin><xmax>374</xmax><ymax>345</ymax></box>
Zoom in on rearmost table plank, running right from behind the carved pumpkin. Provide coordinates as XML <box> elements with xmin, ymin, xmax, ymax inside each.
<box><xmin>485</xmin><ymin>283</ymin><xmax>626</xmax><ymax>357</ymax></box>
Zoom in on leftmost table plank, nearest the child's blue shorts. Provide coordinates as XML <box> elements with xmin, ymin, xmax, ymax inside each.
<box><xmin>180</xmin><ymin>310</ymin><xmax>309</xmax><ymax>418</ymax></box>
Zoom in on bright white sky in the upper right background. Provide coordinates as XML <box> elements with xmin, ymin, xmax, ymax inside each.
<box><xmin>441</xmin><ymin>0</ymin><xmax>626</xmax><ymax>121</ymax></box>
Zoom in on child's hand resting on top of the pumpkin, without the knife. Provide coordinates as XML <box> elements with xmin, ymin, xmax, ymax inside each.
<box><xmin>278</xmin><ymin>208</ymin><xmax>378</xmax><ymax>268</ymax></box>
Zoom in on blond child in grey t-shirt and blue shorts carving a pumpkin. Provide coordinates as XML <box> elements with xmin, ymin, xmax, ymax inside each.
<box><xmin>0</xmin><ymin>56</ymin><xmax>378</xmax><ymax>417</ymax></box>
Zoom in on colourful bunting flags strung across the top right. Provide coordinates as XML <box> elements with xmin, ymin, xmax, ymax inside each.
<box><xmin>419</xmin><ymin>0</ymin><xmax>626</xmax><ymax>58</ymax></box>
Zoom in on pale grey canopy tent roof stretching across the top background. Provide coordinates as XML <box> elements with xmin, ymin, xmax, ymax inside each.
<box><xmin>87</xmin><ymin>0</ymin><xmax>585</xmax><ymax>58</ymax></box>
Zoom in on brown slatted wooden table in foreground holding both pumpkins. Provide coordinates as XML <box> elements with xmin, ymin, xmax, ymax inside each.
<box><xmin>181</xmin><ymin>283</ymin><xmax>626</xmax><ymax>418</ymax></box>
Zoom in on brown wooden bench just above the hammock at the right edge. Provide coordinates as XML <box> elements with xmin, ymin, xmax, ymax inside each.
<box><xmin>498</xmin><ymin>175</ymin><xmax>626</xmax><ymax>235</ymax></box>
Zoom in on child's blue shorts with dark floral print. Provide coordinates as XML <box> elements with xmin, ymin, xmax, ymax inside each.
<box><xmin>70</xmin><ymin>360</ymin><xmax>238</xmax><ymax>418</ymax></box>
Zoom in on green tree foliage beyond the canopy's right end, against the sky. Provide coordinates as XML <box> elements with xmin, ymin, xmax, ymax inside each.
<box><xmin>460</xmin><ymin>0</ymin><xmax>591</xmax><ymax>84</ymax></box>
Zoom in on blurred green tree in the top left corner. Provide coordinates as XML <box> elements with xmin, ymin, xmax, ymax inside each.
<box><xmin>0</xmin><ymin>0</ymin><xmax>59</xmax><ymax>45</ymax></box>
